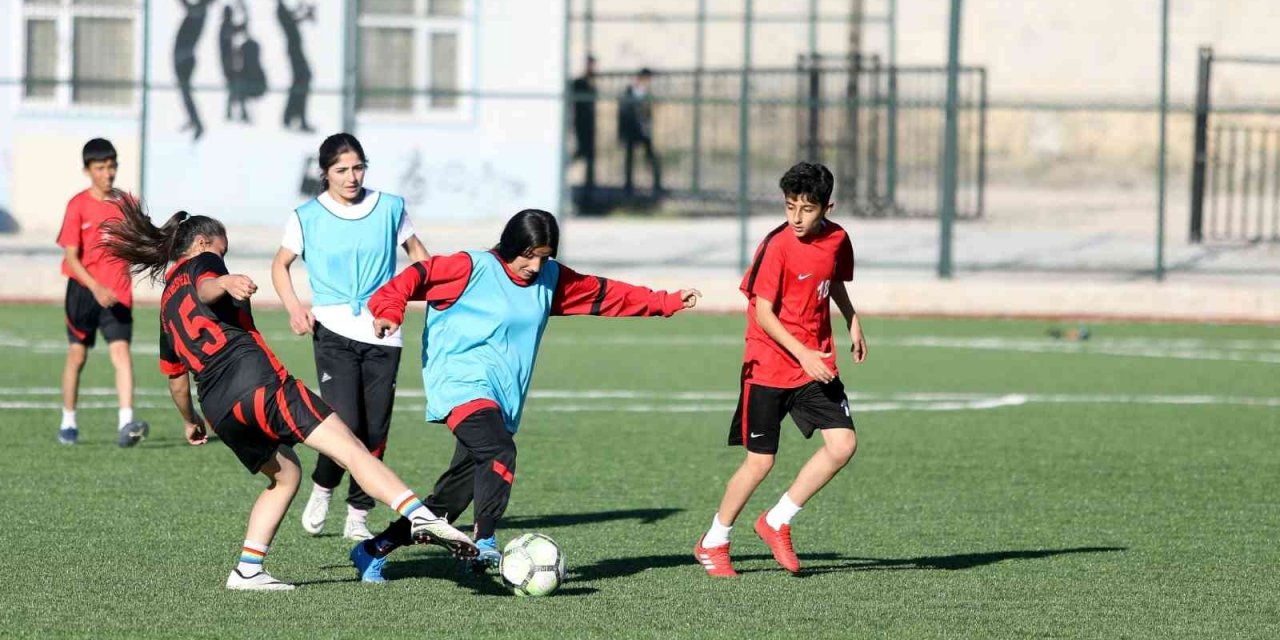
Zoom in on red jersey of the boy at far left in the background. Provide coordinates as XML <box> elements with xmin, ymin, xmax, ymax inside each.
<box><xmin>58</xmin><ymin>189</ymin><xmax>133</xmax><ymax>307</ymax></box>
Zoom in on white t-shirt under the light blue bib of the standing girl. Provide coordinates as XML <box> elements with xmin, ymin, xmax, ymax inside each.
<box><xmin>280</xmin><ymin>189</ymin><xmax>413</xmax><ymax>347</ymax></box>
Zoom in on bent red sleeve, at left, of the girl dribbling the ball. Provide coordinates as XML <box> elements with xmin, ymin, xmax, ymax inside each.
<box><xmin>369</xmin><ymin>253</ymin><xmax>471</xmax><ymax>324</ymax></box>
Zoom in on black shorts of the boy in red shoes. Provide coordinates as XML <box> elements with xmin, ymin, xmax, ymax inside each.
<box><xmin>728</xmin><ymin>378</ymin><xmax>854</xmax><ymax>454</ymax></box>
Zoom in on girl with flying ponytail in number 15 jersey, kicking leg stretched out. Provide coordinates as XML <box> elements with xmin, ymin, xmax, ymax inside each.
<box><xmin>96</xmin><ymin>198</ymin><xmax>476</xmax><ymax>591</ymax></box>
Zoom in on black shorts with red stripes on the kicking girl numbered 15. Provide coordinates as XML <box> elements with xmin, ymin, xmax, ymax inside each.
<box><xmin>205</xmin><ymin>375</ymin><xmax>333</xmax><ymax>474</ymax></box>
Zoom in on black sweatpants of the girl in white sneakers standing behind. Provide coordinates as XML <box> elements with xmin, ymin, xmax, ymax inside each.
<box><xmin>311</xmin><ymin>323</ymin><xmax>401</xmax><ymax>511</ymax></box>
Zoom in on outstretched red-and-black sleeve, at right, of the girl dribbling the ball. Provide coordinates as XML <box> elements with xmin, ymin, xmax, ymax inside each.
<box><xmin>552</xmin><ymin>265</ymin><xmax>685</xmax><ymax>317</ymax></box>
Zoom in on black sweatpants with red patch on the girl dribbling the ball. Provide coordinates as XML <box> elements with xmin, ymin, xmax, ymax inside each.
<box><xmin>425</xmin><ymin>408</ymin><xmax>516</xmax><ymax>539</ymax></box>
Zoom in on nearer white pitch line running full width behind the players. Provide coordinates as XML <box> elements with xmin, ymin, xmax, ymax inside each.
<box><xmin>0</xmin><ymin>387</ymin><xmax>1280</xmax><ymax>413</ymax></box>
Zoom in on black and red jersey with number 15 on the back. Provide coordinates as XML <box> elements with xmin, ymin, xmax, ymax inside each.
<box><xmin>160</xmin><ymin>252</ymin><xmax>288</xmax><ymax>424</ymax></box>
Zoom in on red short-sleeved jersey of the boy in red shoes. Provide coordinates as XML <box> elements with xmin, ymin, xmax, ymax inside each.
<box><xmin>739</xmin><ymin>220</ymin><xmax>854</xmax><ymax>388</ymax></box>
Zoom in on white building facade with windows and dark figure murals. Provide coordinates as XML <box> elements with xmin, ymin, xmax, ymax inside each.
<box><xmin>0</xmin><ymin>0</ymin><xmax>566</xmax><ymax>233</ymax></box>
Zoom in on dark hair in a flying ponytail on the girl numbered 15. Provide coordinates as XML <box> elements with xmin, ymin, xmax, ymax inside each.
<box><xmin>102</xmin><ymin>191</ymin><xmax>227</xmax><ymax>282</ymax></box>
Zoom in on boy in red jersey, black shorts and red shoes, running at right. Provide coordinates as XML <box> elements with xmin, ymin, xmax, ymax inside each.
<box><xmin>694</xmin><ymin>163</ymin><xmax>867</xmax><ymax>577</ymax></box>
